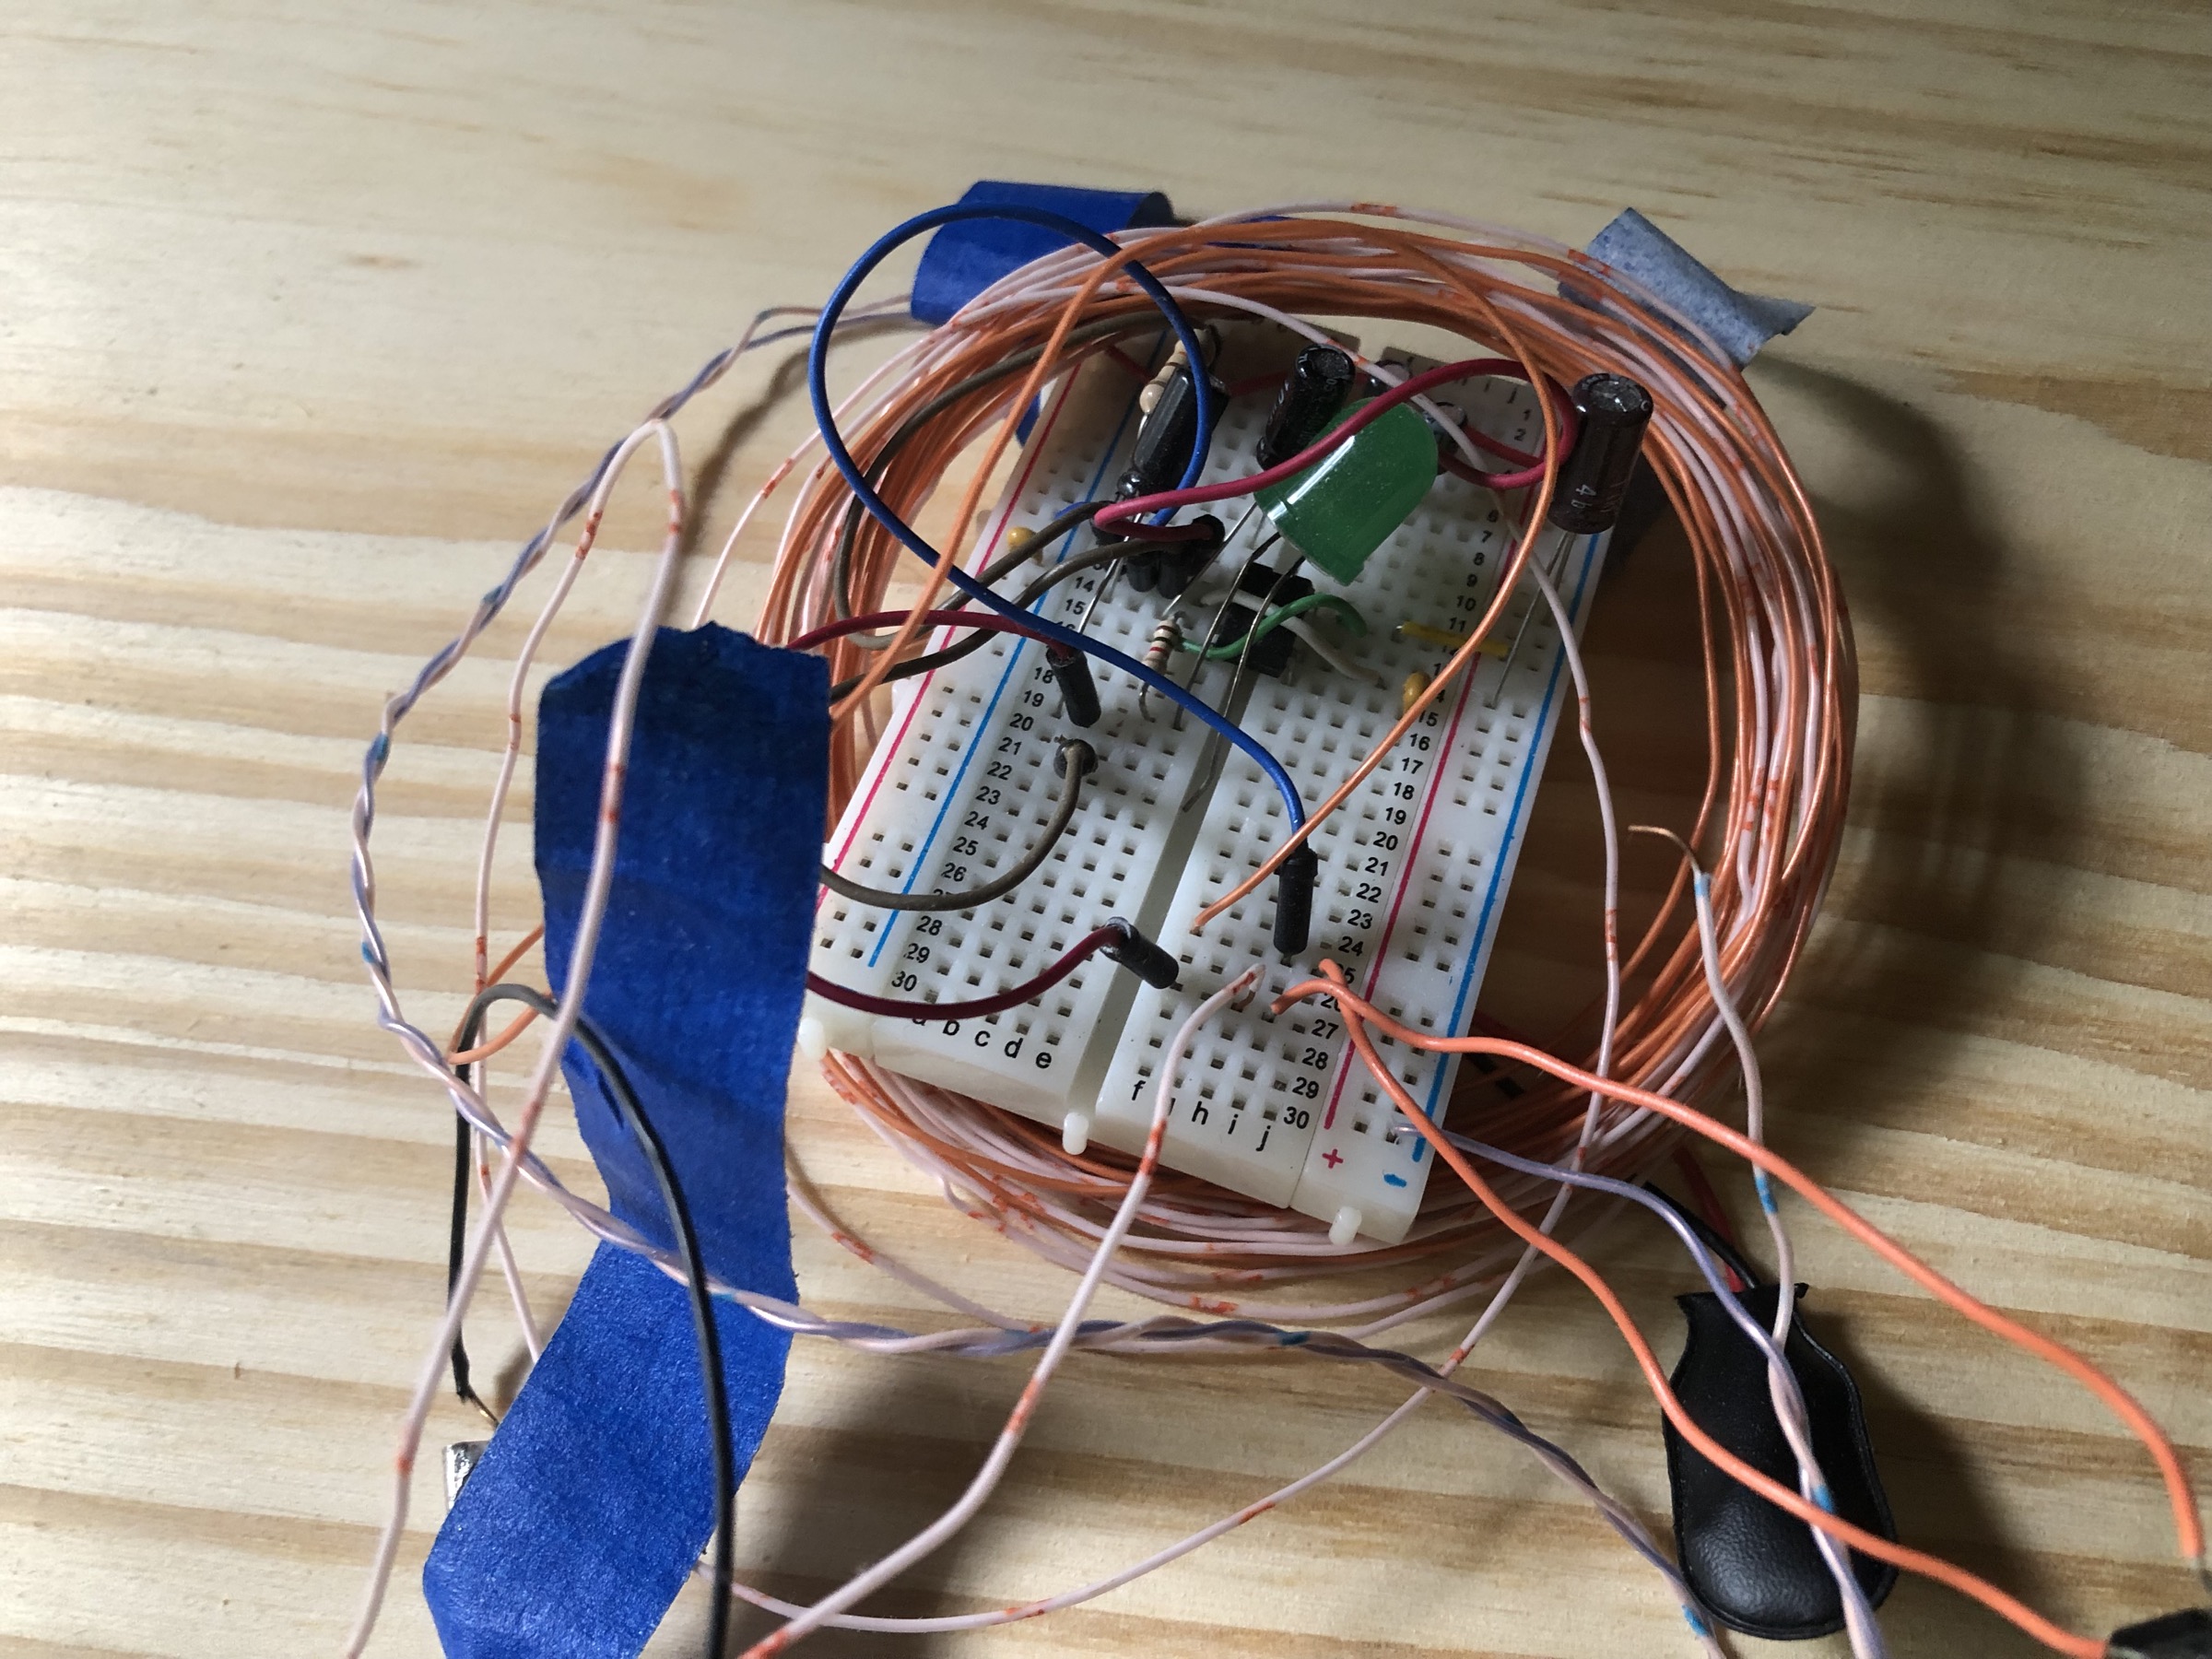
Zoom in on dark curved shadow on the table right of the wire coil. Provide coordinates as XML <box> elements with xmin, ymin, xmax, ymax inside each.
<box><xmin>1760</xmin><ymin>351</ymin><xmax>2084</xmax><ymax>1117</ymax></box>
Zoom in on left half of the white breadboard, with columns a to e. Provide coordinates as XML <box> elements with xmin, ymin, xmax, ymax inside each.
<box><xmin>809</xmin><ymin>351</ymin><xmax>1220</xmax><ymax>1122</ymax></box>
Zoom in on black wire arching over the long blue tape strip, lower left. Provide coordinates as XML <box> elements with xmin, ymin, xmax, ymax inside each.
<box><xmin>447</xmin><ymin>984</ymin><xmax>736</xmax><ymax>1659</ymax></box>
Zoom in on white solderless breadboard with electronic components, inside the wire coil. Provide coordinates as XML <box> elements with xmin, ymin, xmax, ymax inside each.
<box><xmin>807</xmin><ymin>327</ymin><xmax>1604</xmax><ymax>1241</ymax></box>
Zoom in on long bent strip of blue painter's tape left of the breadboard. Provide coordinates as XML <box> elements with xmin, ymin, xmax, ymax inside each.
<box><xmin>422</xmin><ymin>626</ymin><xmax>830</xmax><ymax>1659</ymax></box>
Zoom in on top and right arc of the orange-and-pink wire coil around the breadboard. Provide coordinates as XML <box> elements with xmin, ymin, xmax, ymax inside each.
<box><xmin>763</xmin><ymin>221</ymin><xmax>1852</xmax><ymax>1283</ymax></box>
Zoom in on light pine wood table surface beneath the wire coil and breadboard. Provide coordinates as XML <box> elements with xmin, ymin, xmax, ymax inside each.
<box><xmin>0</xmin><ymin>0</ymin><xmax>2212</xmax><ymax>1659</ymax></box>
